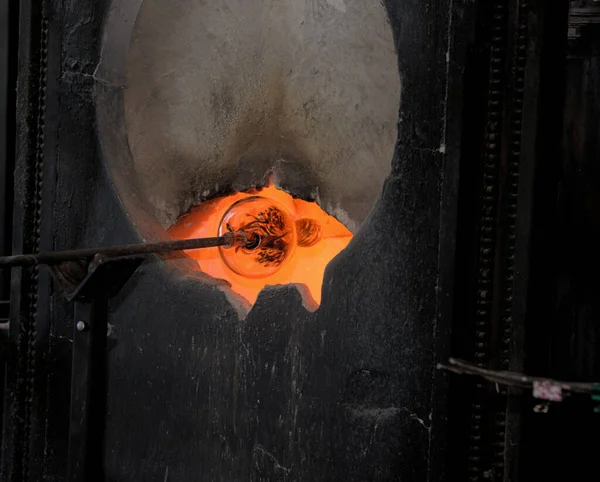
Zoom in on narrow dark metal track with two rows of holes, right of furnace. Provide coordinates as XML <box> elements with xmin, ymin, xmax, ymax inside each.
<box><xmin>469</xmin><ymin>0</ymin><xmax>529</xmax><ymax>482</ymax></box>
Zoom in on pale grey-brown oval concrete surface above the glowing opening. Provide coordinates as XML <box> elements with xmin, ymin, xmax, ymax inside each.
<box><xmin>124</xmin><ymin>0</ymin><xmax>400</xmax><ymax>231</ymax></box>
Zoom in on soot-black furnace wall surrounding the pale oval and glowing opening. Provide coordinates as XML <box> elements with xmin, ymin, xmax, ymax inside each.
<box><xmin>0</xmin><ymin>0</ymin><xmax>464</xmax><ymax>482</ymax></box>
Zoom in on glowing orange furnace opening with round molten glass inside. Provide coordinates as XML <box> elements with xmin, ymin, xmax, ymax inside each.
<box><xmin>169</xmin><ymin>185</ymin><xmax>352</xmax><ymax>306</ymax></box>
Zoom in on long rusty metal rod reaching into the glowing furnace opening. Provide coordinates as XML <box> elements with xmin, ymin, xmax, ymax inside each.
<box><xmin>0</xmin><ymin>233</ymin><xmax>234</xmax><ymax>268</ymax></box>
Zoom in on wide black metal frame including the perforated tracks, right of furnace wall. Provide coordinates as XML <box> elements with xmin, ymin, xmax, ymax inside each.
<box><xmin>447</xmin><ymin>0</ymin><xmax>568</xmax><ymax>480</ymax></box>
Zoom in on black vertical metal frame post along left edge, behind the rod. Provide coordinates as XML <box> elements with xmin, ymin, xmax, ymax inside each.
<box><xmin>1</xmin><ymin>1</ymin><xmax>48</xmax><ymax>481</ymax></box>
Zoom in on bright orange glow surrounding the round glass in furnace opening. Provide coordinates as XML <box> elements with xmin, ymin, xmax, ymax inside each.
<box><xmin>169</xmin><ymin>184</ymin><xmax>352</xmax><ymax>307</ymax></box>
